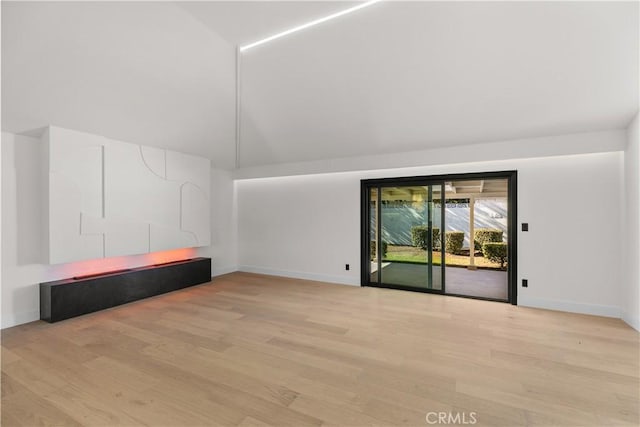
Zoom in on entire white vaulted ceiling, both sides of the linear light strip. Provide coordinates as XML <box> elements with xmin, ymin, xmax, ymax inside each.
<box><xmin>2</xmin><ymin>1</ymin><xmax>640</xmax><ymax>167</ymax></box>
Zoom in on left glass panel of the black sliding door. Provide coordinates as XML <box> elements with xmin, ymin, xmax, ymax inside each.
<box><xmin>367</xmin><ymin>183</ymin><xmax>444</xmax><ymax>292</ymax></box>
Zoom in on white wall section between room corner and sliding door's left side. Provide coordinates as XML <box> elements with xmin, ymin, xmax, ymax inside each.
<box><xmin>236</xmin><ymin>173</ymin><xmax>364</xmax><ymax>285</ymax></box>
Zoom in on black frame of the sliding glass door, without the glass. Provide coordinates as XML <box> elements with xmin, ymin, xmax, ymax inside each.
<box><xmin>360</xmin><ymin>170</ymin><xmax>518</xmax><ymax>305</ymax></box>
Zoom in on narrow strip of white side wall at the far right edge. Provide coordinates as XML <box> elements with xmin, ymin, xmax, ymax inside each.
<box><xmin>622</xmin><ymin>113</ymin><xmax>640</xmax><ymax>330</ymax></box>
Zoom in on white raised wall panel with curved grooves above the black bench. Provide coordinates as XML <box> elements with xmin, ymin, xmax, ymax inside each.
<box><xmin>42</xmin><ymin>127</ymin><xmax>211</xmax><ymax>264</ymax></box>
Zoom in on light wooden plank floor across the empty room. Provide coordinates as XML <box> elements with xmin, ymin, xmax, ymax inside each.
<box><xmin>2</xmin><ymin>273</ymin><xmax>640</xmax><ymax>426</ymax></box>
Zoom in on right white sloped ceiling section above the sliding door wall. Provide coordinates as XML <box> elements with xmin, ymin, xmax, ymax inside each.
<box><xmin>236</xmin><ymin>2</ymin><xmax>639</xmax><ymax>166</ymax></box>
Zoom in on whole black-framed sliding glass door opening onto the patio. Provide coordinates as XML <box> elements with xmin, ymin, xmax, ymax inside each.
<box><xmin>362</xmin><ymin>171</ymin><xmax>517</xmax><ymax>304</ymax></box>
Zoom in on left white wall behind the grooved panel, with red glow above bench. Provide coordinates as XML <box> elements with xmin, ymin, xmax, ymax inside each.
<box><xmin>1</xmin><ymin>132</ymin><xmax>236</xmax><ymax>328</ymax></box>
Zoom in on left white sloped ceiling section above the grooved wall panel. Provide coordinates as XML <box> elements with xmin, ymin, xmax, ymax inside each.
<box><xmin>2</xmin><ymin>2</ymin><xmax>235</xmax><ymax>167</ymax></box>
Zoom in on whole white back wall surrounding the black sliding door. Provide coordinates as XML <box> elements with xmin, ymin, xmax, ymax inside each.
<box><xmin>237</xmin><ymin>141</ymin><xmax>623</xmax><ymax>317</ymax></box>
